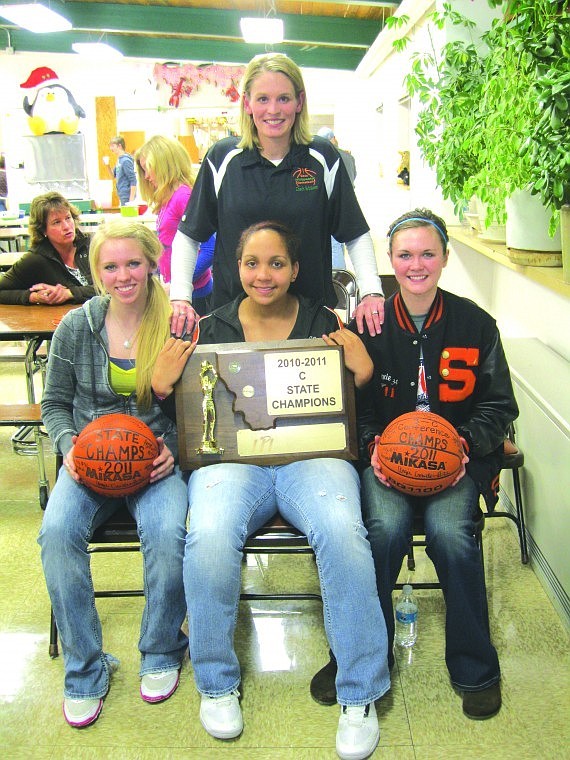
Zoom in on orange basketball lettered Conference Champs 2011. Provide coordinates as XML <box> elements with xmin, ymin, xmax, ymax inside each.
<box><xmin>377</xmin><ymin>412</ymin><xmax>463</xmax><ymax>496</ymax></box>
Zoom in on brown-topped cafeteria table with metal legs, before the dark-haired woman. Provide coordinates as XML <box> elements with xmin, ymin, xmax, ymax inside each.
<box><xmin>0</xmin><ymin>304</ymin><xmax>78</xmax><ymax>509</ymax></box>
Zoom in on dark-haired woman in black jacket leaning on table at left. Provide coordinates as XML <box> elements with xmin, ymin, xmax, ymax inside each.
<box><xmin>0</xmin><ymin>192</ymin><xmax>95</xmax><ymax>306</ymax></box>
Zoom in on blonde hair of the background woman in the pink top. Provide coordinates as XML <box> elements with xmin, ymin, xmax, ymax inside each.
<box><xmin>135</xmin><ymin>135</ymin><xmax>194</xmax><ymax>214</ymax></box>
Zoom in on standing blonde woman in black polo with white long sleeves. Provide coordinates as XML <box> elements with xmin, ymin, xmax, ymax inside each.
<box><xmin>170</xmin><ymin>53</ymin><xmax>384</xmax><ymax>335</ymax></box>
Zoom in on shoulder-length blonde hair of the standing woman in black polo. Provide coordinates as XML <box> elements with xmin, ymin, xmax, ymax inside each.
<box><xmin>238</xmin><ymin>53</ymin><xmax>312</xmax><ymax>150</ymax></box>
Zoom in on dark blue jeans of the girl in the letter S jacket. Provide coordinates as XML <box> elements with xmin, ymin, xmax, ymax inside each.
<box><xmin>362</xmin><ymin>467</ymin><xmax>500</xmax><ymax>691</ymax></box>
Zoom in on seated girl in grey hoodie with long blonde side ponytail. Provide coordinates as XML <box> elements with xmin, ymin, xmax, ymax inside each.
<box><xmin>38</xmin><ymin>218</ymin><xmax>188</xmax><ymax>728</ymax></box>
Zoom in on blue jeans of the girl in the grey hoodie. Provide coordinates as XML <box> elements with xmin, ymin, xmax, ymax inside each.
<box><xmin>38</xmin><ymin>468</ymin><xmax>188</xmax><ymax>699</ymax></box>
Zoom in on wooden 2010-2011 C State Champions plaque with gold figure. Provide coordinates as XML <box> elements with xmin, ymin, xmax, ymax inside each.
<box><xmin>175</xmin><ymin>339</ymin><xmax>358</xmax><ymax>470</ymax></box>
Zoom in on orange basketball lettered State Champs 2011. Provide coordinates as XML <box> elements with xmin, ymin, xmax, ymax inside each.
<box><xmin>73</xmin><ymin>414</ymin><xmax>158</xmax><ymax>497</ymax></box>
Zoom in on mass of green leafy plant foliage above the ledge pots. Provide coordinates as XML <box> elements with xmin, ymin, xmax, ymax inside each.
<box><xmin>387</xmin><ymin>0</ymin><xmax>570</xmax><ymax>242</ymax></box>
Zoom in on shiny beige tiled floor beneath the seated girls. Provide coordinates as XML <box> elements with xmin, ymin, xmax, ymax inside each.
<box><xmin>0</xmin><ymin>354</ymin><xmax>570</xmax><ymax>760</ymax></box>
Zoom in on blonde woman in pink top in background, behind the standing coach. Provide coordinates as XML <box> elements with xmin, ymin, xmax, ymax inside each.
<box><xmin>135</xmin><ymin>135</ymin><xmax>215</xmax><ymax>315</ymax></box>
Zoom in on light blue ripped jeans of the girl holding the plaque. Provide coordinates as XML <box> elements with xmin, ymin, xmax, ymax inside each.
<box><xmin>184</xmin><ymin>459</ymin><xmax>390</xmax><ymax>705</ymax></box>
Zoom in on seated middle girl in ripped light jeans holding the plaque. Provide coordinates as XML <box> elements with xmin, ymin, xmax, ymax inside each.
<box><xmin>152</xmin><ymin>222</ymin><xmax>390</xmax><ymax>758</ymax></box>
